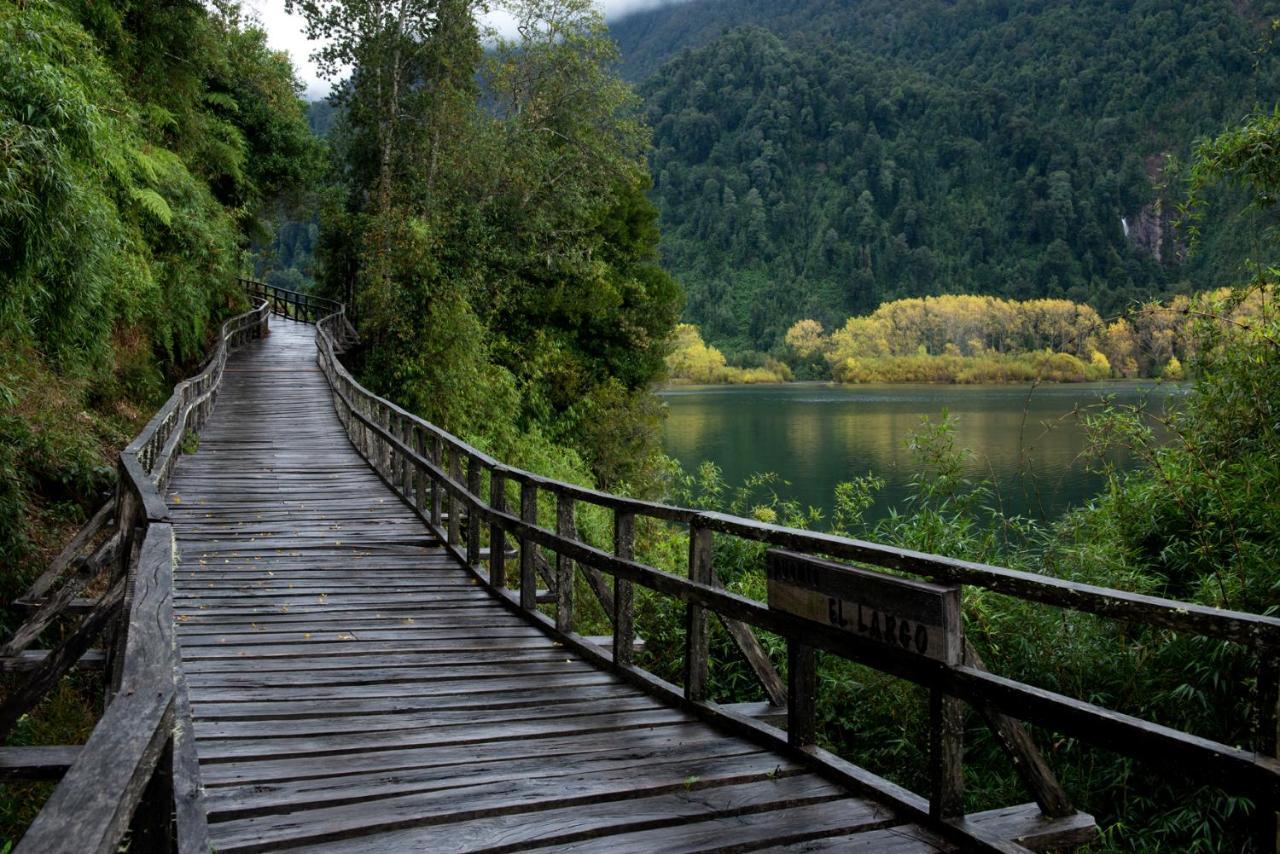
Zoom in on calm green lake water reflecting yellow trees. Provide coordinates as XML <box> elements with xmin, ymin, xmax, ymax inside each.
<box><xmin>659</xmin><ymin>382</ymin><xmax>1185</xmax><ymax>520</ymax></box>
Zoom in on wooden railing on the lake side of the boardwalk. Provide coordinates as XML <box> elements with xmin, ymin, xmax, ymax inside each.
<box><xmin>317</xmin><ymin>290</ymin><xmax>1280</xmax><ymax>851</ymax></box>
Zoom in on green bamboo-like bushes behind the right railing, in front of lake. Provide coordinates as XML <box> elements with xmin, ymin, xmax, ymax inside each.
<box><xmin>637</xmin><ymin>345</ymin><xmax>1280</xmax><ymax>851</ymax></box>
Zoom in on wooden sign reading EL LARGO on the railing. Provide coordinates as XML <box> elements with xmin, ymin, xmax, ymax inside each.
<box><xmin>765</xmin><ymin>549</ymin><xmax>964</xmax><ymax>665</ymax></box>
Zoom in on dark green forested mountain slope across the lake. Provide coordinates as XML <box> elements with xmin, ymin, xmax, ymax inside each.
<box><xmin>611</xmin><ymin>0</ymin><xmax>1280</xmax><ymax>351</ymax></box>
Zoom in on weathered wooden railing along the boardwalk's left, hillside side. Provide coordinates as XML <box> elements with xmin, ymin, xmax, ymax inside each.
<box><xmin>0</xmin><ymin>291</ymin><xmax>270</xmax><ymax>853</ymax></box>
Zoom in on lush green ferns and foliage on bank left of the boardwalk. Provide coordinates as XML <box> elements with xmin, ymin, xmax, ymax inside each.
<box><xmin>0</xmin><ymin>0</ymin><xmax>317</xmax><ymax>600</ymax></box>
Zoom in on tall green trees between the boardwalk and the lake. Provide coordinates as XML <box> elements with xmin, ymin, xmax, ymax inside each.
<box><xmin>309</xmin><ymin>0</ymin><xmax>680</xmax><ymax>490</ymax></box>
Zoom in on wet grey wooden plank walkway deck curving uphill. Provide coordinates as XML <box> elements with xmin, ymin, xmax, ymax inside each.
<box><xmin>168</xmin><ymin>319</ymin><xmax>940</xmax><ymax>853</ymax></box>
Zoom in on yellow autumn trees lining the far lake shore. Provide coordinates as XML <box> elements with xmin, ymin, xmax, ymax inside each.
<box><xmin>667</xmin><ymin>288</ymin><xmax>1262</xmax><ymax>385</ymax></box>
